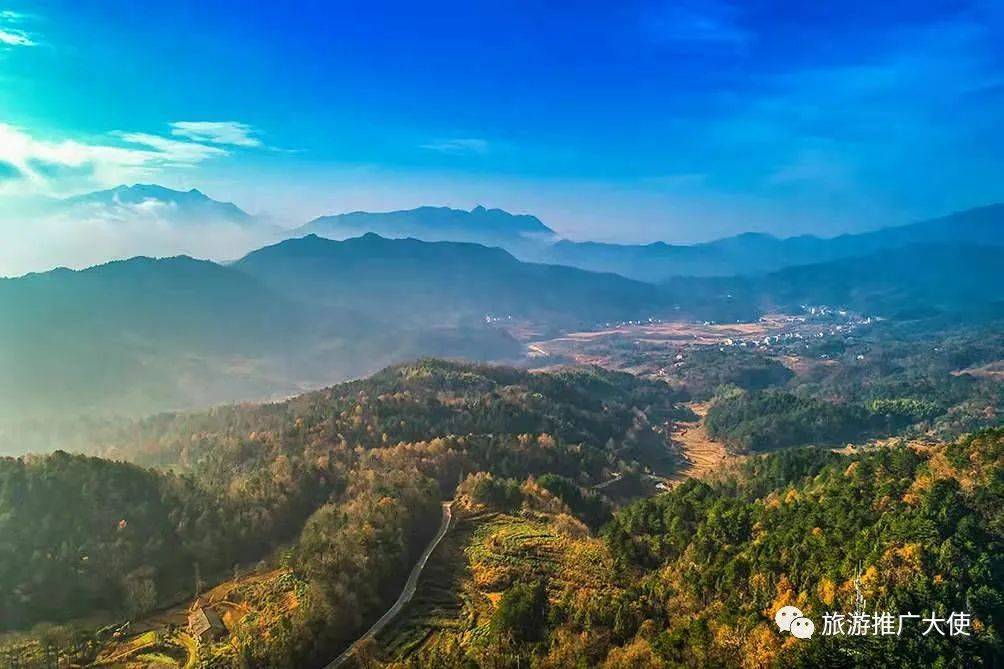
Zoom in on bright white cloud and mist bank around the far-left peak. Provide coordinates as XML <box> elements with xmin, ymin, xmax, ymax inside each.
<box><xmin>0</xmin><ymin>118</ymin><xmax>273</xmax><ymax>275</ymax></box>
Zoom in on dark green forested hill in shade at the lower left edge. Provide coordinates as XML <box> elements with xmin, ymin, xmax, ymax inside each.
<box><xmin>0</xmin><ymin>452</ymin><xmax>313</xmax><ymax>629</ymax></box>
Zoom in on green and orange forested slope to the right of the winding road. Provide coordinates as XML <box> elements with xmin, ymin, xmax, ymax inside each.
<box><xmin>381</xmin><ymin>429</ymin><xmax>1004</xmax><ymax>669</ymax></box>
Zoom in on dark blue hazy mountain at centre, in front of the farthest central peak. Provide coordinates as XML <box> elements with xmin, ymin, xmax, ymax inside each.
<box><xmin>232</xmin><ymin>234</ymin><xmax>661</xmax><ymax>326</ymax></box>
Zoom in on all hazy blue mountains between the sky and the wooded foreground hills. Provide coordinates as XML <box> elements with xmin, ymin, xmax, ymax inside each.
<box><xmin>0</xmin><ymin>180</ymin><xmax>1004</xmax><ymax>420</ymax></box>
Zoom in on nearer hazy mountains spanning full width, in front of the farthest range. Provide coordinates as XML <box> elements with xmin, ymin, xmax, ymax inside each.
<box><xmin>0</xmin><ymin>224</ymin><xmax>1004</xmax><ymax>420</ymax></box>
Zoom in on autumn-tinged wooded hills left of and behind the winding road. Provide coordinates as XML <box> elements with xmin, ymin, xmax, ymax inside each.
<box><xmin>0</xmin><ymin>361</ymin><xmax>676</xmax><ymax>666</ymax></box>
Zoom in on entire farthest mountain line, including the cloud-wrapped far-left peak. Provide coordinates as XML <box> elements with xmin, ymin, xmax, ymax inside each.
<box><xmin>17</xmin><ymin>184</ymin><xmax>1004</xmax><ymax>283</ymax></box>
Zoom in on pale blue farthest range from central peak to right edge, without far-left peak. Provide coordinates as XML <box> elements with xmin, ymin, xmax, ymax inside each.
<box><xmin>298</xmin><ymin>198</ymin><xmax>1004</xmax><ymax>282</ymax></box>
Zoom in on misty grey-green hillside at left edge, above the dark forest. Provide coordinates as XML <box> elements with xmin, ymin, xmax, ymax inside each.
<box><xmin>0</xmin><ymin>257</ymin><xmax>304</xmax><ymax>418</ymax></box>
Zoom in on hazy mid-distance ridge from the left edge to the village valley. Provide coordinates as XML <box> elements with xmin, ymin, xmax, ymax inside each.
<box><xmin>0</xmin><ymin>235</ymin><xmax>661</xmax><ymax>419</ymax></box>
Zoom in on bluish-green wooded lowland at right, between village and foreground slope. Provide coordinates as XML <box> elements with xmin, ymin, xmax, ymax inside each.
<box><xmin>682</xmin><ymin>322</ymin><xmax>1004</xmax><ymax>452</ymax></box>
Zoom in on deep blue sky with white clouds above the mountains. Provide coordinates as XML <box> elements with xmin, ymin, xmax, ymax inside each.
<box><xmin>0</xmin><ymin>0</ymin><xmax>1004</xmax><ymax>241</ymax></box>
